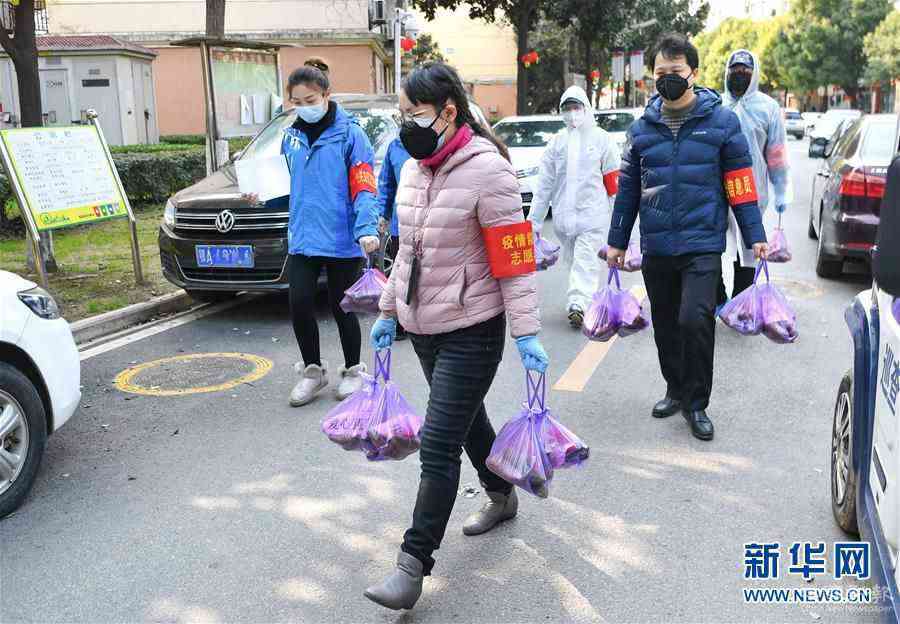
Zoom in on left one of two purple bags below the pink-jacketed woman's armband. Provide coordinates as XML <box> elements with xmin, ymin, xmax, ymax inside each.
<box><xmin>485</xmin><ymin>373</ymin><xmax>553</xmax><ymax>498</ymax></box>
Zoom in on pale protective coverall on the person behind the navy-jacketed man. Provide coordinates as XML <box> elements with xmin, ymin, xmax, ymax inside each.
<box><xmin>722</xmin><ymin>50</ymin><xmax>794</xmax><ymax>267</ymax></box>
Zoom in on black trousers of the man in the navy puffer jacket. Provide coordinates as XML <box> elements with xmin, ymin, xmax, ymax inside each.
<box><xmin>642</xmin><ymin>254</ymin><xmax>722</xmax><ymax>411</ymax></box>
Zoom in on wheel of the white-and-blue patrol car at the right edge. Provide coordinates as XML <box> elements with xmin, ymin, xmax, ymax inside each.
<box><xmin>831</xmin><ymin>371</ymin><xmax>859</xmax><ymax>535</ymax></box>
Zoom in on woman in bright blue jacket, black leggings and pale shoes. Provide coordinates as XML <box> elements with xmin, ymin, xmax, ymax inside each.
<box><xmin>281</xmin><ymin>64</ymin><xmax>379</xmax><ymax>407</ymax></box>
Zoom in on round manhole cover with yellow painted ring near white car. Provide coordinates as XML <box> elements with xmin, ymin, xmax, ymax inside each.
<box><xmin>114</xmin><ymin>353</ymin><xmax>272</xmax><ymax>396</ymax></box>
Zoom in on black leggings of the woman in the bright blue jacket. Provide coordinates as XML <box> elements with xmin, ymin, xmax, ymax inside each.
<box><xmin>288</xmin><ymin>255</ymin><xmax>362</xmax><ymax>368</ymax></box>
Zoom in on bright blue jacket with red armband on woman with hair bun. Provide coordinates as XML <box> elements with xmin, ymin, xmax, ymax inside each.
<box><xmin>281</xmin><ymin>106</ymin><xmax>378</xmax><ymax>258</ymax></box>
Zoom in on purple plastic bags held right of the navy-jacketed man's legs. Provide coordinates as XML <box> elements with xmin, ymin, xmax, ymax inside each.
<box><xmin>719</xmin><ymin>260</ymin><xmax>798</xmax><ymax>344</ymax></box>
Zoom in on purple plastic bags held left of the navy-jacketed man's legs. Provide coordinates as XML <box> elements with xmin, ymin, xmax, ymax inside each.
<box><xmin>581</xmin><ymin>267</ymin><xmax>650</xmax><ymax>342</ymax></box>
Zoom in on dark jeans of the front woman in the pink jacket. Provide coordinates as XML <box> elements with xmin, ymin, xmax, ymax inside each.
<box><xmin>401</xmin><ymin>314</ymin><xmax>512</xmax><ymax>575</ymax></box>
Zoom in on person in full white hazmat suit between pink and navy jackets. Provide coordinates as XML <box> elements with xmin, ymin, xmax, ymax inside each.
<box><xmin>528</xmin><ymin>86</ymin><xmax>620</xmax><ymax>328</ymax></box>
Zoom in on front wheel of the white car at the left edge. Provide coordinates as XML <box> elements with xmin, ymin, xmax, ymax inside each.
<box><xmin>0</xmin><ymin>362</ymin><xmax>47</xmax><ymax>518</ymax></box>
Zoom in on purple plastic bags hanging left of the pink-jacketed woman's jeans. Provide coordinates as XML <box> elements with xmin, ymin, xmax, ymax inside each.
<box><xmin>322</xmin><ymin>350</ymin><xmax>422</xmax><ymax>461</ymax></box>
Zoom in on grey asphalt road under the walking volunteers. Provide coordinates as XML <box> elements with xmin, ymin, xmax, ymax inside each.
<box><xmin>0</xmin><ymin>140</ymin><xmax>875</xmax><ymax>623</ymax></box>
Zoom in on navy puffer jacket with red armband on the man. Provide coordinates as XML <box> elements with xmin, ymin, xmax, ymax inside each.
<box><xmin>609</xmin><ymin>88</ymin><xmax>766</xmax><ymax>256</ymax></box>
